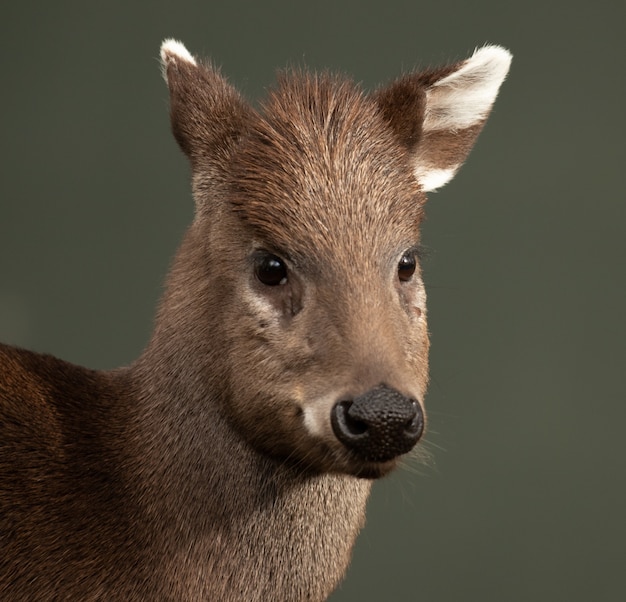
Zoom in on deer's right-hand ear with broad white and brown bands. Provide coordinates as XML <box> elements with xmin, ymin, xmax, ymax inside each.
<box><xmin>376</xmin><ymin>46</ymin><xmax>511</xmax><ymax>191</ymax></box>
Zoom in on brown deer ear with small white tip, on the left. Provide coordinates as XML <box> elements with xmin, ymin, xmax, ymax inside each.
<box><xmin>161</xmin><ymin>39</ymin><xmax>248</xmax><ymax>176</ymax></box>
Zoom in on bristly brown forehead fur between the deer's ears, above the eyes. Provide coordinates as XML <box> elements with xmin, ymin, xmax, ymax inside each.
<box><xmin>232</xmin><ymin>72</ymin><xmax>424</xmax><ymax>253</ymax></box>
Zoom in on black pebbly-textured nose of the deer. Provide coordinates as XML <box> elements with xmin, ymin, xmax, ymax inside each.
<box><xmin>331</xmin><ymin>385</ymin><xmax>424</xmax><ymax>462</ymax></box>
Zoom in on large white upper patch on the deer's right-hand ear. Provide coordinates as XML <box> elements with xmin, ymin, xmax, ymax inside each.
<box><xmin>424</xmin><ymin>46</ymin><xmax>512</xmax><ymax>131</ymax></box>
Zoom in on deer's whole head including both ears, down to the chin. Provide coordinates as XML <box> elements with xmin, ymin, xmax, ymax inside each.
<box><xmin>162</xmin><ymin>41</ymin><xmax>508</xmax><ymax>477</ymax></box>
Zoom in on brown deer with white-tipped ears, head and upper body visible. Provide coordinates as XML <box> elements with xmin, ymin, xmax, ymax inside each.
<box><xmin>0</xmin><ymin>39</ymin><xmax>511</xmax><ymax>602</ymax></box>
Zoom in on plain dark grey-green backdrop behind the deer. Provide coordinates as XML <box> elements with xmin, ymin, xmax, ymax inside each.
<box><xmin>0</xmin><ymin>0</ymin><xmax>626</xmax><ymax>602</ymax></box>
